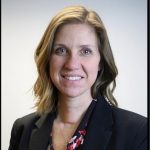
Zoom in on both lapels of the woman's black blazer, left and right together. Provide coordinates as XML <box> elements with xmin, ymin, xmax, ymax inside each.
<box><xmin>29</xmin><ymin>97</ymin><xmax>113</xmax><ymax>150</ymax></box>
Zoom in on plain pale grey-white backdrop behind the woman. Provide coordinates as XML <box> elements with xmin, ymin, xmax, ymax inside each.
<box><xmin>2</xmin><ymin>0</ymin><xmax>147</xmax><ymax>150</ymax></box>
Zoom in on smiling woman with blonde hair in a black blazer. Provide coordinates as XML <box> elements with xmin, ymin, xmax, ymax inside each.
<box><xmin>9</xmin><ymin>6</ymin><xmax>147</xmax><ymax>150</ymax></box>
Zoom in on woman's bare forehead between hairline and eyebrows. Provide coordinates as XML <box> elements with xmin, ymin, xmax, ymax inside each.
<box><xmin>54</xmin><ymin>23</ymin><xmax>97</xmax><ymax>44</ymax></box>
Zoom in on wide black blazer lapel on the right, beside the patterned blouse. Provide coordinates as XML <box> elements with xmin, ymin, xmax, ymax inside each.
<box><xmin>83</xmin><ymin>97</ymin><xmax>113</xmax><ymax>150</ymax></box>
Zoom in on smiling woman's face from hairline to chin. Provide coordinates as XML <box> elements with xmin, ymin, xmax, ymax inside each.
<box><xmin>50</xmin><ymin>24</ymin><xmax>100</xmax><ymax>98</ymax></box>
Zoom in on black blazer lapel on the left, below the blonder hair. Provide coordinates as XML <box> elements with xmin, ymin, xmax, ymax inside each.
<box><xmin>29</xmin><ymin>113</ymin><xmax>54</xmax><ymax>150</ymax></box>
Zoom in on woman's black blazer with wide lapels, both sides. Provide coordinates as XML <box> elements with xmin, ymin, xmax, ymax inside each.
<box><xmin>9</xmin><ymin>97</ymin><xmax>147</xmax><ymax>150</ymax></box>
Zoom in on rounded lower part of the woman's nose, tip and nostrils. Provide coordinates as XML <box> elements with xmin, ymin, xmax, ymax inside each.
<box><xmin>64</xmin><ymin>55</ymin><xmax>80</xmax><ymax>71</ymax></box>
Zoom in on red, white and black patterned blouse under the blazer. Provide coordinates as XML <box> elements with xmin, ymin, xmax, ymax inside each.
<box><xmin>47</xmin><ymin>99</ymin><xmax>97</xmax><ymax>150</ymax></box>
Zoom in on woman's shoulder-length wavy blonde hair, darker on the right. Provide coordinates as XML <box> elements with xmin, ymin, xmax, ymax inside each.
<box><xmin>34</xmin><ymin>6</ymin><xmax>118</xmax><ymax>114</ymax></box>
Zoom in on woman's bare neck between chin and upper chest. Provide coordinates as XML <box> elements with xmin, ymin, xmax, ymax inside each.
<box><xmin>57</xmin><ymin>96</ymin><xmax>92</xmax><ymax>124</ymax></box>
